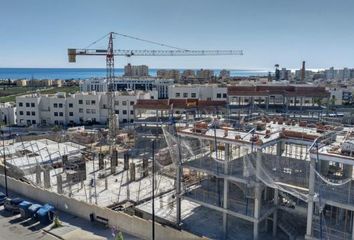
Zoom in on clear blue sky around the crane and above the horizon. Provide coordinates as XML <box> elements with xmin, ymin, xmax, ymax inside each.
<box><xmin>0</xmin><ymin>0</ymin><xmax>354</xmax><ymax>69</ymax></box>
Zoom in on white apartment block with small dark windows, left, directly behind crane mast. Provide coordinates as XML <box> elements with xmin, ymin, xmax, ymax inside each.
<box><xmin>16</xmin><ymin>91</ymin><xmax>157</xmax><ymax>126</ymax></box>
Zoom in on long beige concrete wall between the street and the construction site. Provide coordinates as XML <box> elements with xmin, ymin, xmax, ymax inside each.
<box><xmin>0</xmin><ymin>175</ymin><xmax>202</xmax><ymax>240</ymax></box>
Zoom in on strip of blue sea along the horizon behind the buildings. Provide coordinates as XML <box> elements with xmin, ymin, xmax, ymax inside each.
<box><xmin>0</xmin><ymin>68</ymin><xmax>268</xmax><ymax>80</ymax></box>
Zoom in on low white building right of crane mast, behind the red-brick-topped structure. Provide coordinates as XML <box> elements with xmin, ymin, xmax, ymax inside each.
<box><xmin>168</xmin><ymin>84</ymin><xmax>227</xmax><ymax>100</ymax></box>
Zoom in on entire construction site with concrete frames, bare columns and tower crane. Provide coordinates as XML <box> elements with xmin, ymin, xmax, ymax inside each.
<box><xmin>0</xmin><ymin>33</ymin><xmax>354</xmax><ymax>240</ymax></box>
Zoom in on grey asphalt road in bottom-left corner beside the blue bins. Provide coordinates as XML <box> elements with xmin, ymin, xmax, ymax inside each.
<box><xmin>0</xmin><ymin>206</ymin><xmax>58</xmax><ymax>240</ymax></box>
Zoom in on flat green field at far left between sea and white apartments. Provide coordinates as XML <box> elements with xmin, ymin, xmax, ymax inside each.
<box><xmin>0</xmin><ymin>86</ymin><xmax>79</xmax><ymax>103</ymax></box>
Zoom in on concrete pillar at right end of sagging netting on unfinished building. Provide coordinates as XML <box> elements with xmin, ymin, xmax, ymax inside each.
<box><xmin>306</xmin><ymin>159</ymin><xmax>316</xmax><ymax>238</ymax></box>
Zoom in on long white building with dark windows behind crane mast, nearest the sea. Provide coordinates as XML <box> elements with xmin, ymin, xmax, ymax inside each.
<box><xmin>80</xmin><ymin>77</ymin><xmax>173</xmax><ymax>99</ymax></box>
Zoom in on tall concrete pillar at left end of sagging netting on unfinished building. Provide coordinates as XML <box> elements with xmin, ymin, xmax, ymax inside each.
<box><xmin>253</xmin><ymin>149</ymin><xmax>262</xmax><ymax>239</ymax></box>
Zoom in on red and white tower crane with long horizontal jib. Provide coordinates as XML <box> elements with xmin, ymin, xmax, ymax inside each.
<box><xmin>68</xmin><ymin>32</ymin><xmax>243</xmax><ymax>152</ymax></box>
